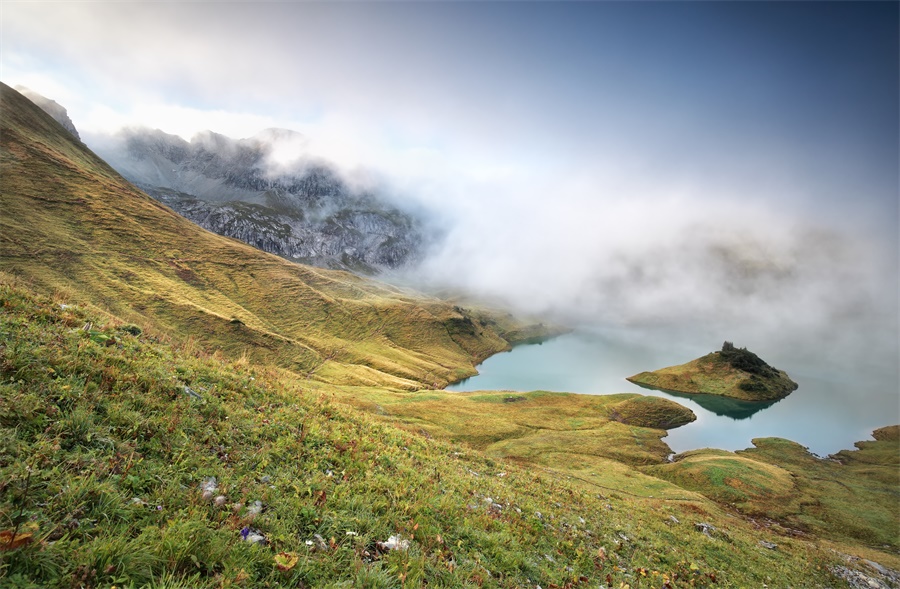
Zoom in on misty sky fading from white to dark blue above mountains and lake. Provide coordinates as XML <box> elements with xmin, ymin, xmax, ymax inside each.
<box><xmin>0</xmin><ymin>0</ymin><xmax>900</xmax><ymax>368</ymax></box>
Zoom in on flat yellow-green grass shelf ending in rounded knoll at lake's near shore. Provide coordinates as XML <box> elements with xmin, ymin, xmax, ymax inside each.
<box><xmin>324</xmin><ymin>389</ymin><xmax>695</xmax><ymax>465</ymax></box>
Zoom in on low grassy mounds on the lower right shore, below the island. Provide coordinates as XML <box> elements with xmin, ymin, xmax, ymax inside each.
<box><xmin>644</xmin><ymin>434</ymin><xmax>900</xmax><ymax>565</ymax></box>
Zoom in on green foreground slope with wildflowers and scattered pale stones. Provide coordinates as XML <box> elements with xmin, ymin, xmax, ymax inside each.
<box><xmin>0</xmin><ymin>282</ymin><xmax>880</xmax><ymax>588</ymax></box>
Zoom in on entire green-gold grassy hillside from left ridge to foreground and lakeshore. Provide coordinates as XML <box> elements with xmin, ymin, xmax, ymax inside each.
<box><xmin>0</xmin><ymin>86</ymin><xmax>900</xmax><ymax>589</ymax></box>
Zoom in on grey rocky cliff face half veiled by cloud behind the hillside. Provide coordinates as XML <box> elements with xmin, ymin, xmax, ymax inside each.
<box><xmin>95</xmin><ymin>129</ymin><xmax>423</xmax><ymax>274</ymax></box>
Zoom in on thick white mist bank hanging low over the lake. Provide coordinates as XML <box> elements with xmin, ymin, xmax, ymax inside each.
<box><xmin>398</xmin><ymin>172</ymin><xmax>898</xmax><ymax>373</ymax></box>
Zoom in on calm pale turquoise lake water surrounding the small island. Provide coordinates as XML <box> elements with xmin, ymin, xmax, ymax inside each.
<box><xmin>447</xmin><ymin>332</ymin><xmax>900</xmax><ymax>456</ymax></box>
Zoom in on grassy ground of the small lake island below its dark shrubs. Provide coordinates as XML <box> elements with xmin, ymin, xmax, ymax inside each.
<box><xmin>628</xmin><ymin>352</ymin><xmax>797</xmax><ymax>401</ymax></box>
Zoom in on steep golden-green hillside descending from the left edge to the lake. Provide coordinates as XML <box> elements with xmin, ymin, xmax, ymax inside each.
<box><xmin>0</xmin><ymin>79</ymin><xmax>548</xmax><ymax>388</ymax></box>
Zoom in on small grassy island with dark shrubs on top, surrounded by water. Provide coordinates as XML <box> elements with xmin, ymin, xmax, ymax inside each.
<box><xmin>626</xmin><ymin>342</ymin><xmax>797</xmax><ymax>401</ymax></box>
